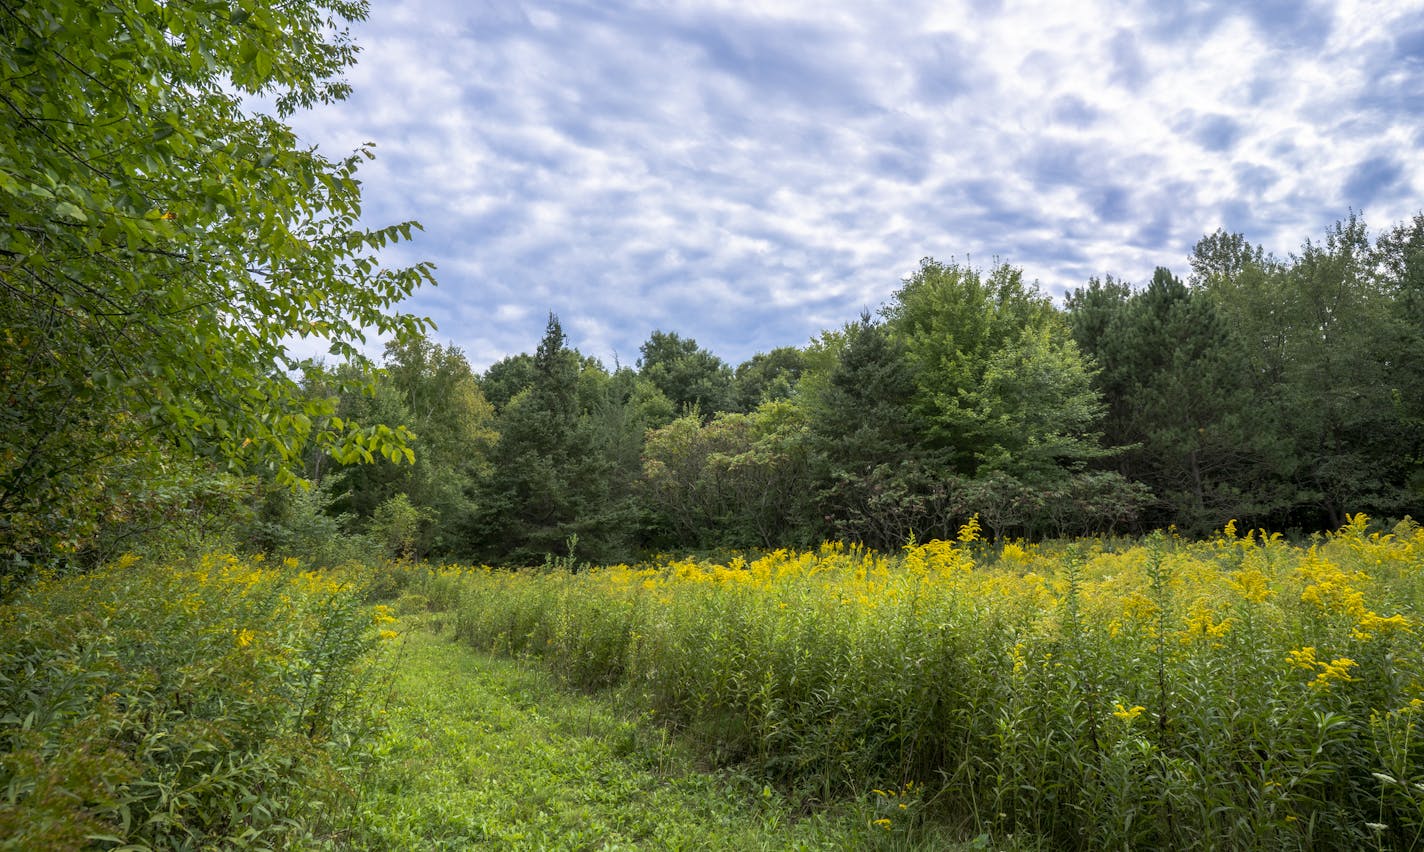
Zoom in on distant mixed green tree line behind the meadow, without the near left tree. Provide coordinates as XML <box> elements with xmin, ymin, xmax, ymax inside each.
<box><xmin>253</xmin><ymin>215</ymin><xmax>1424</xmax><ymax>563</ymax></box>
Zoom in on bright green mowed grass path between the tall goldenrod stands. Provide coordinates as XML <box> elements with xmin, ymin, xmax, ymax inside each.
<box><xmin>342</xmin><ymin>624</ymin><xmax>968</xmax><ymax>849</ymax></box>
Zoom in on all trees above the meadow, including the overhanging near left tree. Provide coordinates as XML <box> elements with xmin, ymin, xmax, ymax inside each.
<box><xmin>8</xmin><ymin>0</ymin><xmax>1424</xmax><ymax>578</ymax></box>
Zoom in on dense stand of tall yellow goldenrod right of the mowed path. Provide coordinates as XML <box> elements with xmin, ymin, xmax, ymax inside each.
<box><xmin>435</xmin><ymin>516</ymin><xmax>1424</xmax><ymax>849</ymax></box>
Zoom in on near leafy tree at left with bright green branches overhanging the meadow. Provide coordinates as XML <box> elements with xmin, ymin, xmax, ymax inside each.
<box><xmin>0</xmin><ymin>0</ymin><xmax>433</xmax><ymax>559</ymax></box>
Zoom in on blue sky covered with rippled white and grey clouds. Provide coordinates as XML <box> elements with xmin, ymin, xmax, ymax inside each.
<box><xmin>289</xmin><ymin>0</ymin><xmax>1424</xmax><ymax>370</ymax></box>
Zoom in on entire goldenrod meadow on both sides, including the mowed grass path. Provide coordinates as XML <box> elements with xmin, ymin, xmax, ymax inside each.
<box><xmin>0</xmin><ymin>516</ymin><xmax>1424</xmax><ymax>849</ymax></box>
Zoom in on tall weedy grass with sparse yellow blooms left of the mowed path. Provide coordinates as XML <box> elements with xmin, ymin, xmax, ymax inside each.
<box><xmin>0</xmin><ymin>557</ymin><xmax>389</xmax><ymax>849</ymax></box>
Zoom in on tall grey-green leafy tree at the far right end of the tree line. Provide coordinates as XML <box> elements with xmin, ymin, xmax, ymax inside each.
<box><xmin>1192</xmin><ymin>215</ymin><xmax>1417</xmax><ymax>529</ymax></box>
